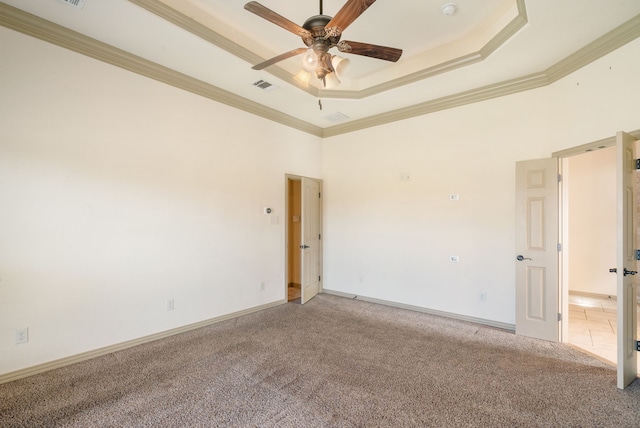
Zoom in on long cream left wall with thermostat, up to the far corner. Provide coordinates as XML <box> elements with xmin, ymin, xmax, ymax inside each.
<box><xmin>0</xmin><ymin>28</ymin><xmax>321</xmax><ymax>374</ymax></box>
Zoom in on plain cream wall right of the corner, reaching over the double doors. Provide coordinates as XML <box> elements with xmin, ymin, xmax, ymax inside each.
<box><xmin>323</xmin><ymin>40</ymin><xmax>640</xmax><ymax>325</ymax></box>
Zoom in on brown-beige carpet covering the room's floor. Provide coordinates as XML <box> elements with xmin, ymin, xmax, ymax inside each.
<box><xmin>0</xmin><ymin>294</ymin><xmax>640</xmax><ymax>428</ymax></box>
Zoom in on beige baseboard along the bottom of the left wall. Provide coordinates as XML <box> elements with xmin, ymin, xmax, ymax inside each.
<box><xmin>0</xmin><ymin>299</ymin><xmax>287</xmax><ymax>384</ymax></box>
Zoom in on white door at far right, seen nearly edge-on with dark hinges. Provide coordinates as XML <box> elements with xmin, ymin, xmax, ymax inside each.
<box><xmin>616</xmin><ymin>132</ymin><xmax>637</xmax><ymax>389</ymax></box>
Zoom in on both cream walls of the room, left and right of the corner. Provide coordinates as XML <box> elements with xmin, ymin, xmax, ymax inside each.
<box><xmin>0</xmin><ymin>23</ymin><xmax>640</xmax><ymax>374</ymax></box>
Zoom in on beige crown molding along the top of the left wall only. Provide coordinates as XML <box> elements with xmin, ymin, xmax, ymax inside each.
<box><xmin>0</xmin><ymin>3</ymin><xmax>322</xmax><ymax>137</ymax></box>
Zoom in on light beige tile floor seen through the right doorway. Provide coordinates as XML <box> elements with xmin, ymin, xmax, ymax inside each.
<box><xmin>569</xmin><ymin>295</ymin><xmax>640</xmax><ymax>373</ymax></box>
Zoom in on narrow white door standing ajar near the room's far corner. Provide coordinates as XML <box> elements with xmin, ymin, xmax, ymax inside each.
<box><xmin>300</xmin><ymin>178</ymin><xmax>322</xmax><ymax>303</ymax></box>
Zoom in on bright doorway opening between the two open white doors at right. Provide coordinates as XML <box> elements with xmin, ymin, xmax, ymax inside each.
<box><xmin>559</xmin><ymin>139</ymin><xmax>640</xmax><ymax>375</ymax></box>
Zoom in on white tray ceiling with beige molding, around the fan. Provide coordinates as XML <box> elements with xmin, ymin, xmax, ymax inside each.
<box><xmin>0</xmin><ymin>0</ymin><xmax>640</xmax><ymax>137</ymax></box>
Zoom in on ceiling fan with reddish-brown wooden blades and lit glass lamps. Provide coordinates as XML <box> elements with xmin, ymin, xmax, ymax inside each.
<box><xmin>244</xmin><ymin>0</ymin><xmax>402</xmax><ymax>87</ymax></box>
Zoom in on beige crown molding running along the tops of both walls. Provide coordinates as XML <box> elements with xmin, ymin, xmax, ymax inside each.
<box><xmin>0</xmin><ymin>0</ymin><xmax>640</xmax><ymax>138</ymax></box>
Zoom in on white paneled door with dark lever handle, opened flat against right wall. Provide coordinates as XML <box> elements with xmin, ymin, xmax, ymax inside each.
<box><xmin>515</xmin><ymin>158</ymin><xmax>559</xmax><ymax>342</ymax></box>
